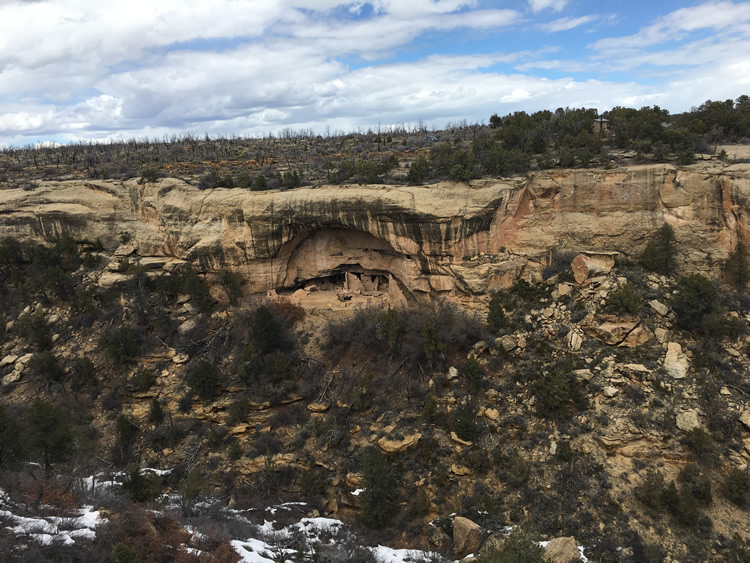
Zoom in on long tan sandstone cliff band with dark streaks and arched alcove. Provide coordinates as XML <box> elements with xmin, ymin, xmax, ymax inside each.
<box><xmin>0</xmin><ymin>165</ymin><xmax>750</xmax><ymax>296</ymax></box>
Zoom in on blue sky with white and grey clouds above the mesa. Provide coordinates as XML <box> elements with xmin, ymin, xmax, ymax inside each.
<box><xmin>0</xmin><ymin>0</ymin><xmax>750</xmax><ymax>146</ymax></box>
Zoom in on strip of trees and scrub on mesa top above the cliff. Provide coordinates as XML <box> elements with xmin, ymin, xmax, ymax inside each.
<box><xmin>0</xmin><ymin>95</ymin><xmax>750</xmax><ymax>190</ymax></box>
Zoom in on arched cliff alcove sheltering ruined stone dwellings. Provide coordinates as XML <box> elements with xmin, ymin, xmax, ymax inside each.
<box><xmin>277</xmin><ymin>229</ymin><xmax>421</xmax><ymax>304</ymax></box>
